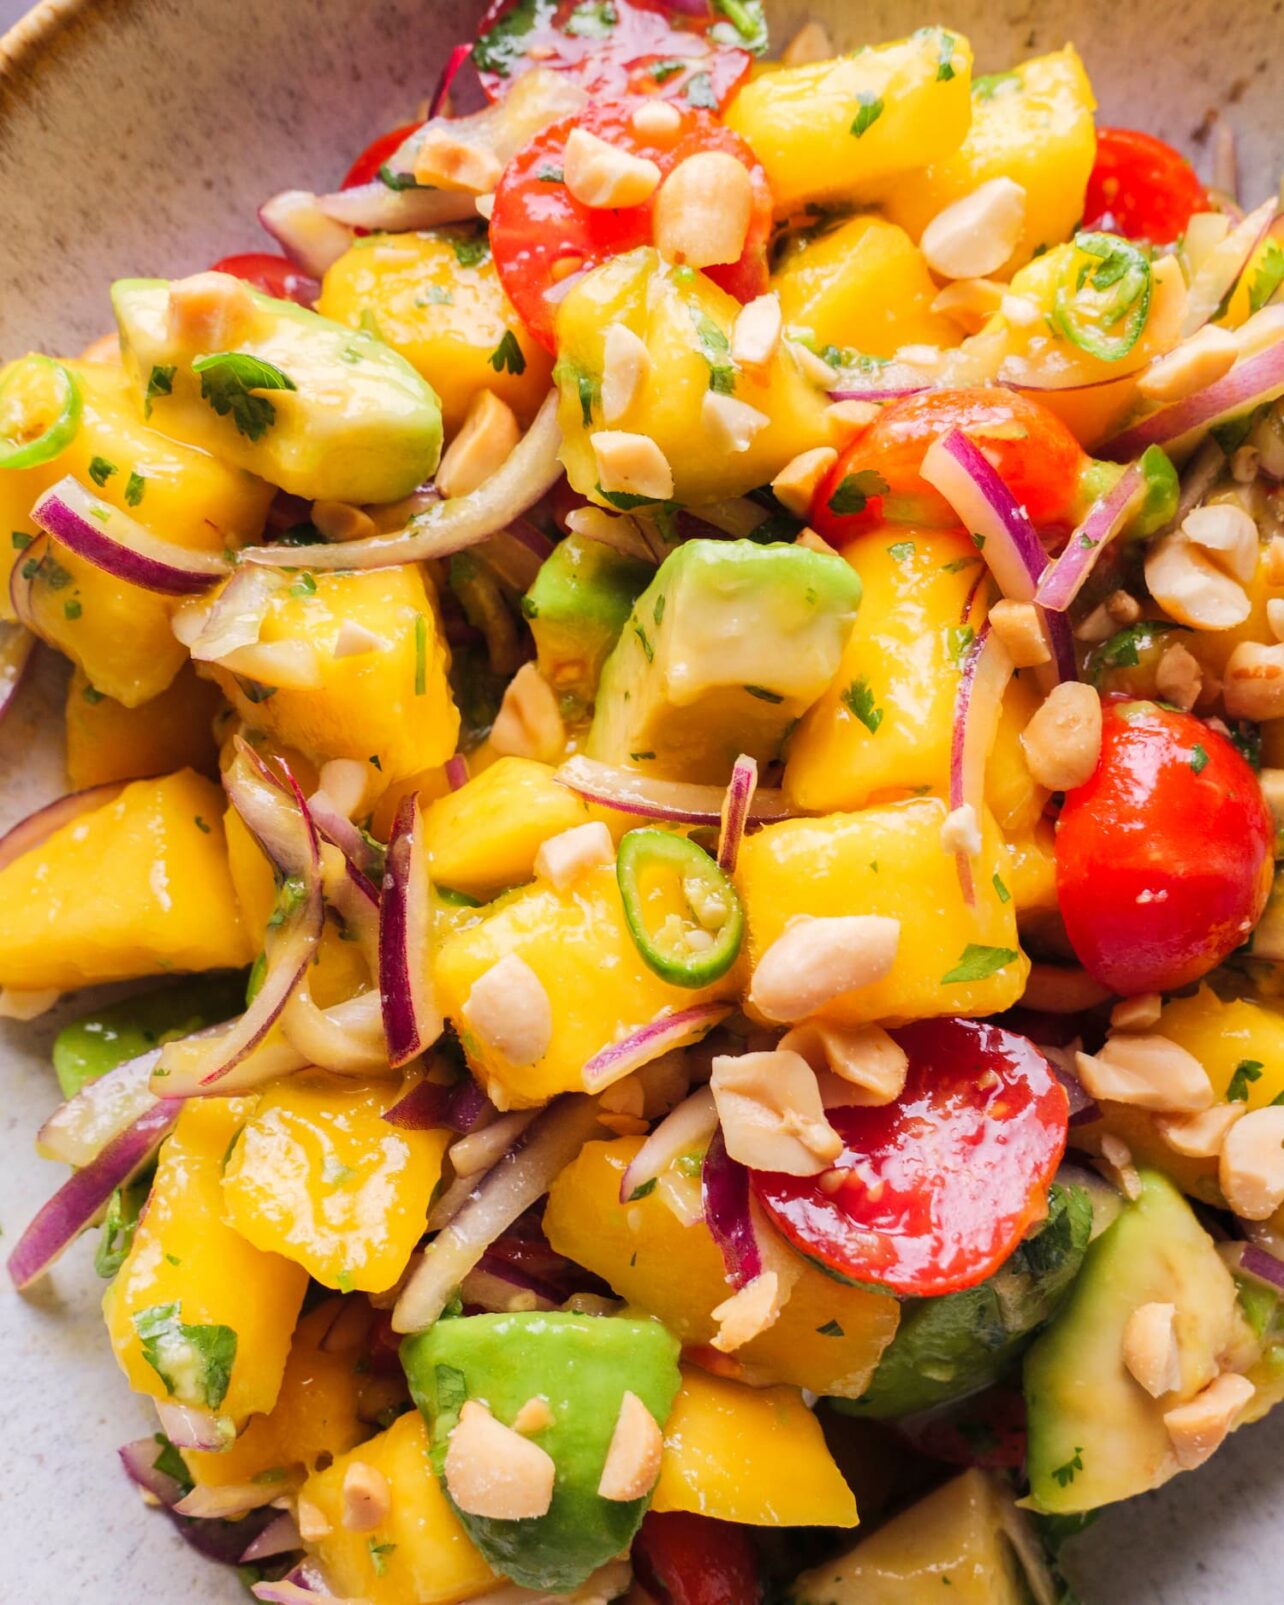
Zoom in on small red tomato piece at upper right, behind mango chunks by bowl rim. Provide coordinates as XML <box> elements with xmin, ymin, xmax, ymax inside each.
<box><xmin>1082</xmin><ymin>128</ymin><xmax>1209</xmax><ymax>246</ymax></box>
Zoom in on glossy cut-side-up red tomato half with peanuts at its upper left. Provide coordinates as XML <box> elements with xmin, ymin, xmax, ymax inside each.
<box><xmin>753</xmin><ymin>1019</ymin><xmax>1069</xmax><ymax>1298</ymax></box>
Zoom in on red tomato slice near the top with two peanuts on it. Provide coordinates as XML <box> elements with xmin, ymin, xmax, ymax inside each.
<box><xmin>491</xmin><ymin>100</ymin><xmax>772</xmax><ymax>350</ymax></box>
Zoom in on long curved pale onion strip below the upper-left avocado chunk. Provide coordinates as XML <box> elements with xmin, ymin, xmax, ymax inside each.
<box><xmin>241</xmin><ymin>393</ymin><xmax>562</xmax><ymax>570</ymax></box>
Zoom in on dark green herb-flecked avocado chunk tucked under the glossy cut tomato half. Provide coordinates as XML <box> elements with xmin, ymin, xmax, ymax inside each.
<box><xmin>835</xmin><ymin>1186</ymin><xmax>1093</xmax><ymax>1420</ymax></box>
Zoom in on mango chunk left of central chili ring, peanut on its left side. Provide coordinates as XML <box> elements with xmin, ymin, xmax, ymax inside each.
<box><xmin>435</xmin><ymin>863</ymin><xmax>738</xmax><ymax>1107</ymax></box>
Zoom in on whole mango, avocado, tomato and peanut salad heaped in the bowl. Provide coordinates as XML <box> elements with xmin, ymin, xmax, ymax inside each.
<box><xmin>0</xmin><ymin>0</ymin><xmax>1284</xmax><ymax>1605</ymax></box>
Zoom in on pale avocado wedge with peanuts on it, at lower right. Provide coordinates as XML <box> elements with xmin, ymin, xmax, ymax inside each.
<box><xmin>1024</xmin><ymin>1172</ymin><xmax>1249</xmax><ymax>1515</ymax></box>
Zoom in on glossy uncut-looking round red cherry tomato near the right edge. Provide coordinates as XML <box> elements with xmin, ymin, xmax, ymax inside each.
<box><xmin>1056</xmin><ymin>700</ymin><xmax>1274</xmax><ymax>997</ymax></box>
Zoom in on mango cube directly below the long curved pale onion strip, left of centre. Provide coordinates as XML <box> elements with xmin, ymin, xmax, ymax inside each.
<box><xmin>209</xmin><ymin>565</ymin><xmax>459</xmax><ymax>780</ymax></box>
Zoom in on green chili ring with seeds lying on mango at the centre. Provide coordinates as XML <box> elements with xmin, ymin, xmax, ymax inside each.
<box><xmin>615</xmin><ymin>828</ymin><xmax>745</xmax><ymax>987</ymax></box>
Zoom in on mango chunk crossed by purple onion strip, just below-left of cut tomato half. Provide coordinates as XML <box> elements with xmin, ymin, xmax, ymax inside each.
<box><xmin>544</xmin><ymin>1136</ymin><xmax>900</xmax><ymax>1398</ymax></box>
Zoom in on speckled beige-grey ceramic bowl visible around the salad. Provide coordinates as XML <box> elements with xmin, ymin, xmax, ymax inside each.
<box><xmin>0</xmin><ymin>0</ymin><xmax>1284</xmax><ymax>1605</ymax></box>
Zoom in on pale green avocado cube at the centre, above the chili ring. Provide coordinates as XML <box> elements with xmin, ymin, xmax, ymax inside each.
<box><xmin>587</xmin><ymin>541</ymin><xmax>860</xmax><ymax>785</ymax></box>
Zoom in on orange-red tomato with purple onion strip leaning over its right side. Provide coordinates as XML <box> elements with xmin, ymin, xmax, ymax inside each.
<box><xmin>811</xmin><ymin>388</ymin><xmax>1088</xmax><ymax>546</ymax></box>
